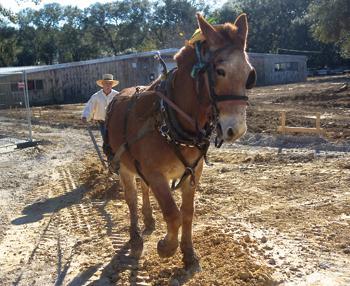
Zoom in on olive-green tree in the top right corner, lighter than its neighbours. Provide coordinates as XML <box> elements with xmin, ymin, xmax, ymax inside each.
<box><xmin>308</xmin><ymin>0</ymin><xmax>350</xmax><ymax>58</ymax></box>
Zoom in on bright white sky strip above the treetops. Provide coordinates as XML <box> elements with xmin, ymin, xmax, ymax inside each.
<box><xmin>0</xmin><ymin>0</ymin><xmax>226</xmax><ymax>13</ymax></box>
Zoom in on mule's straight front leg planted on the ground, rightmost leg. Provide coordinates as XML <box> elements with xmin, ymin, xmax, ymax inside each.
<box><xmin>181</xmin><ymin>161</ymin><xmax>203</xmax><ymax>272</ymax></box>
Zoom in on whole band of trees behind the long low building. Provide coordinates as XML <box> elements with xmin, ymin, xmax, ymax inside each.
<box><xmin>0</xmin><ymin>0</ymin><xmax>350</xmax><ymax>66</ymax></box>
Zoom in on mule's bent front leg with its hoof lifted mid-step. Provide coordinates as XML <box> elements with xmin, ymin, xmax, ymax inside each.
<box><xmin>149</xmin><ymin>174</ymin><xmax>181</xmax><ymax>257</ymax></box>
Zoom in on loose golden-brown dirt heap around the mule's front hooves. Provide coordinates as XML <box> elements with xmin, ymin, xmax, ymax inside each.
<box><xmin>143</xmin><ymin>227</ymin><xmax>275</xmax><ymax>286</ymax></box>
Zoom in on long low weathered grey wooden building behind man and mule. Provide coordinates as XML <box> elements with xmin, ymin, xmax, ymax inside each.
<box><xmin>0</xmin><ymin>49</ymin><xmax>306</xmax><ymax>107</ymax></box>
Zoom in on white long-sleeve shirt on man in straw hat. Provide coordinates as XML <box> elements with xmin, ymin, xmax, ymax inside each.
<box><xmin>82</xmin><ymin>89</ymin><xmax>119</xmax><ymax>121</ymax></box>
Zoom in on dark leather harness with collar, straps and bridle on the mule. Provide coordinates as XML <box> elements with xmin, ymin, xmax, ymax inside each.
<box><xmin>109</xmin><ymin>42</ymin><xmax>248</xmax><ymax>189</ymax></box>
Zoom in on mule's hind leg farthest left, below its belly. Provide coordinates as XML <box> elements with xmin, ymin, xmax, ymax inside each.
<box><xmin>120</xmin><ymin>166</ymin><xmax>143</xmax><ymax>257</ymax></box>
